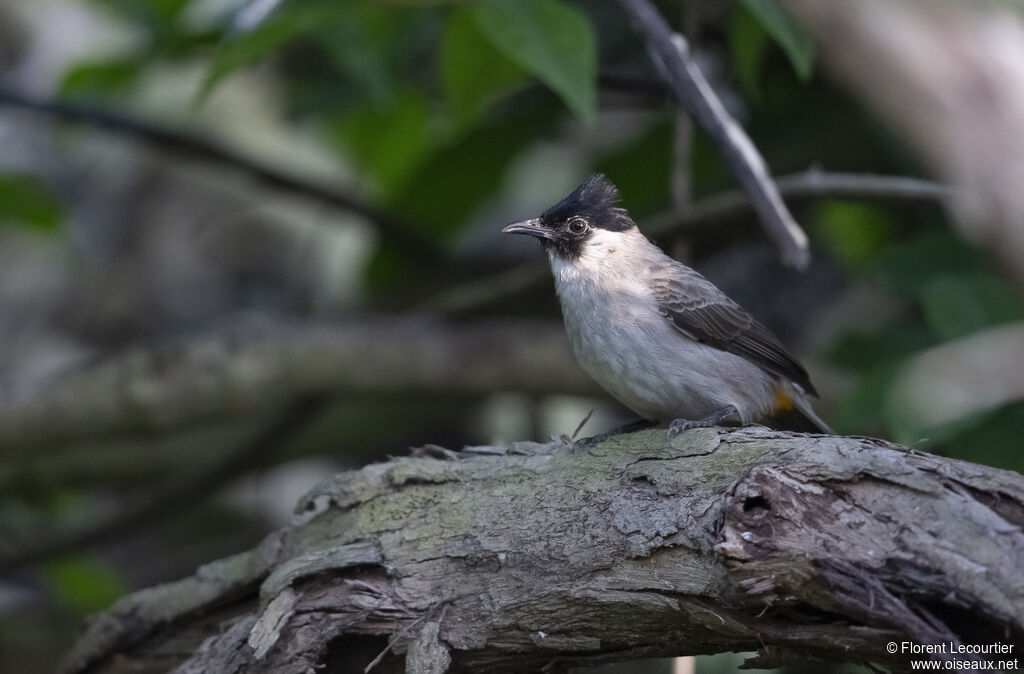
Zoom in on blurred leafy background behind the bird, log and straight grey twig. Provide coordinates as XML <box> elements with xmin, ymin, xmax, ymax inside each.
<box><xmin>0</xmin><ymin>0</ymin><xmax>1024</xmax><ymax>674</ymax></box>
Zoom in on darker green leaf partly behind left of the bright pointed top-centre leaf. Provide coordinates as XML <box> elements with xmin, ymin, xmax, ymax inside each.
<box><xmin>440</xmin><ymin>7</ymin><xmax>528</xmax><ymax>126</ymax></box>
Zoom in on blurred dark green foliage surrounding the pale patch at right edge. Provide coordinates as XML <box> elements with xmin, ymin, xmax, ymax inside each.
<box><xmin>829</xmin><ymin>228</ymin><xmax>1024</xmax><ymax>454</ymax></box>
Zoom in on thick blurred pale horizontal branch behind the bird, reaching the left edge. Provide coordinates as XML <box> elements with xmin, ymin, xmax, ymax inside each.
<box><xmin>0</xmin><ymin>318</ymin><xmax>597</xmax><ymax>450</ymax></box>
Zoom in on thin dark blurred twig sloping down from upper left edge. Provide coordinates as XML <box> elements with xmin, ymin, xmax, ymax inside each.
<box><xmin>0</xmin><ymin>87</ymin><xmax>437</xmax><ymax>258</ymax></box>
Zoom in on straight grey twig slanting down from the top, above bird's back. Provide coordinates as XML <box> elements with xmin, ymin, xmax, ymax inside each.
<box><xmin>618</xmin><ymin>0</ymin><xmax>810</xmax><ymax>268</ymax></box>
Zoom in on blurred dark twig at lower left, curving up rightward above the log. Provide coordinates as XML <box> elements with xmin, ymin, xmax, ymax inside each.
<box><xmin>0</xmin><ymin>396</ymin><xmax>330</xmax><ymax>574</ymax></box>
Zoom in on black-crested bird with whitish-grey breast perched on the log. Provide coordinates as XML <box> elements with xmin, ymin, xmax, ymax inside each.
<box><xmin>502</xmin><ymin>173</ymin><xmax>833</xmax><ymax>437</ymax></box>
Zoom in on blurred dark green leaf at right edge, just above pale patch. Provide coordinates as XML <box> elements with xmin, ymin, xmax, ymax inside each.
<box><xmin>921</xmin><ymin>275</ymin><xmax>1024</xmax><ymax>339</ymax></box>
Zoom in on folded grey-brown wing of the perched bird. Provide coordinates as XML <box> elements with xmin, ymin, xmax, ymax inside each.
<box><xmin>650</xmin><ymin>261</ymin><xmax>817</xmax><ymax>395</ymax></box>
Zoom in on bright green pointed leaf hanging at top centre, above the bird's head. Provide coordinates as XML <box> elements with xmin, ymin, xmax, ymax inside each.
<box><xmin>472</xmin><ymin>0</ymin><xmax>597</xmax><ymax>121</ymax></box>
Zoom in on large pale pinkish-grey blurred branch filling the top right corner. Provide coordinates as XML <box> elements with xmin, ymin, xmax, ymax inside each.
<box><xmin>785</xmin><ymin>0</ymin><xmax>1024</xmax><ymax>283</ymax></box>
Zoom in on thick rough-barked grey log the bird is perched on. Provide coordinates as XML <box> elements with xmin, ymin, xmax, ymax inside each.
<box><xmin>58</xmin><ymin>427</ymin><xmax>1024</xmax><ymax>674</ymax></box>
